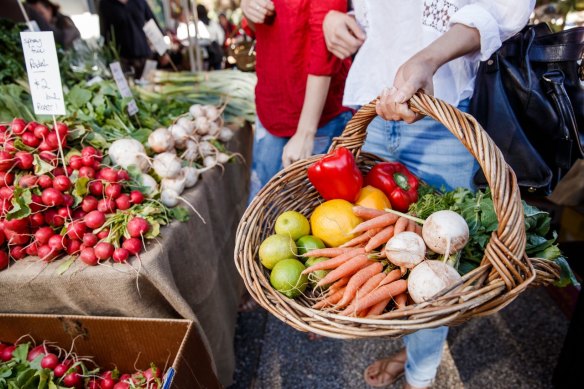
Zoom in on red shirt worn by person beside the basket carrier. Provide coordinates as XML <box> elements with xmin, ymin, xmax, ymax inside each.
<box><xmin>255</xmin><ymin>0</ymin><xmax>351</xmax><ymax>137</ymax></box>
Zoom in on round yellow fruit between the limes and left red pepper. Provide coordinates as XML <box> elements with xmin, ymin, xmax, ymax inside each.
<box><xmin>310</xmin><ymin>199</ymin><xmax>362</xmax><ymax>247</ymax></box>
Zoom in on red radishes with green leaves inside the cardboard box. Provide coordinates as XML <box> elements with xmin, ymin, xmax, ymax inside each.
<box><xmin>0</xmin><ymin>337</ymin><xmax>163</xmax><ymax>389</ymax></box>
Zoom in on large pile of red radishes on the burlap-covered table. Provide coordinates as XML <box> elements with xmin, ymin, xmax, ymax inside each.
<box><xmin>0</xmin><ymin>119</ymin><xmax>149</xmax><ymax>270</ymax></box>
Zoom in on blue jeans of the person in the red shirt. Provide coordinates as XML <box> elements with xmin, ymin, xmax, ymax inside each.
<box><xmin>247</xmin><ymin>111</ymin><xmax>353</xmax><ymax>204</ymax></box>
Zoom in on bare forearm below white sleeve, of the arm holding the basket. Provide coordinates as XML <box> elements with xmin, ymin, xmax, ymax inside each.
<box><xmin>416</xmin><ymin>24</ymin><xmax>481</xmax><ymax>72</ymax></box>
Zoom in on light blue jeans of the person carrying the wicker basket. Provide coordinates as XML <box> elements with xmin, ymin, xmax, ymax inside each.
<box><xmin>363</xmin><ymin>100</ymin><xmax>478</xmax><ymax>387</ymax></box>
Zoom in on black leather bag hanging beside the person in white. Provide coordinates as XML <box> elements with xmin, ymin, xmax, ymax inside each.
<box><xmin>469</xmin><ymin>24</ymin><xmax>584</xmax><ymax>194</ymax></box>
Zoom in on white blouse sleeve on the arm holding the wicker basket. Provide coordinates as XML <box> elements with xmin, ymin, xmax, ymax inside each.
<box><xmin>450</xmin><ymin>0</ymin><xmax>535</xmax><ymax>61</ymax></box>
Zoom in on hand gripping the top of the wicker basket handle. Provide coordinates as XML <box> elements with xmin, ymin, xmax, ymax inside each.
<box><xmin>375</xmin><ymin>56</ymin><xmax>436</xmax><ymax>123</ymax></box>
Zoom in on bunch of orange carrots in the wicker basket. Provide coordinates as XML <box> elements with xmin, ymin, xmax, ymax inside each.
<box><xmin>303</xmin><ymin>206</ymin><xmax>421</xmax><ymax>317</ymax></box>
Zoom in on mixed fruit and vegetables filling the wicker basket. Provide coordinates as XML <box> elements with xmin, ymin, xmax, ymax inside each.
<box><xmin>258</xmin><ymin>148</ymin><xmax>565</xmax><ymax>317</ymax></box>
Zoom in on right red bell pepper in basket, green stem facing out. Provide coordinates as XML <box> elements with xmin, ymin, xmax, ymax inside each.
<box><xmin>365</xmin><ymin>162</ymin><xmax>419</xmax><ymax>212</ymax></box>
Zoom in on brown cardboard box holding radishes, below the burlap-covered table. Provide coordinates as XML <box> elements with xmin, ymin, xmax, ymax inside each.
<box><xmin>0</xmin><ymin>314</ymin><xmax>221</xmax><ymax>389</ymax></box>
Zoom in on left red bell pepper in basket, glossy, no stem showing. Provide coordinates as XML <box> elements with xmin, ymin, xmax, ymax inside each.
<box><xmin>308</xmin><ymin>147</ymin><xmax>363</xmax><ymax>202</ymax></box>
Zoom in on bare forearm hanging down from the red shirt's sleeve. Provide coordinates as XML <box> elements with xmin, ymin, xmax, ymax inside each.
<box><xmin>298</xmin><ymin>74</ymin><xmax>331</xmax><ymax>135</ymax></box>
